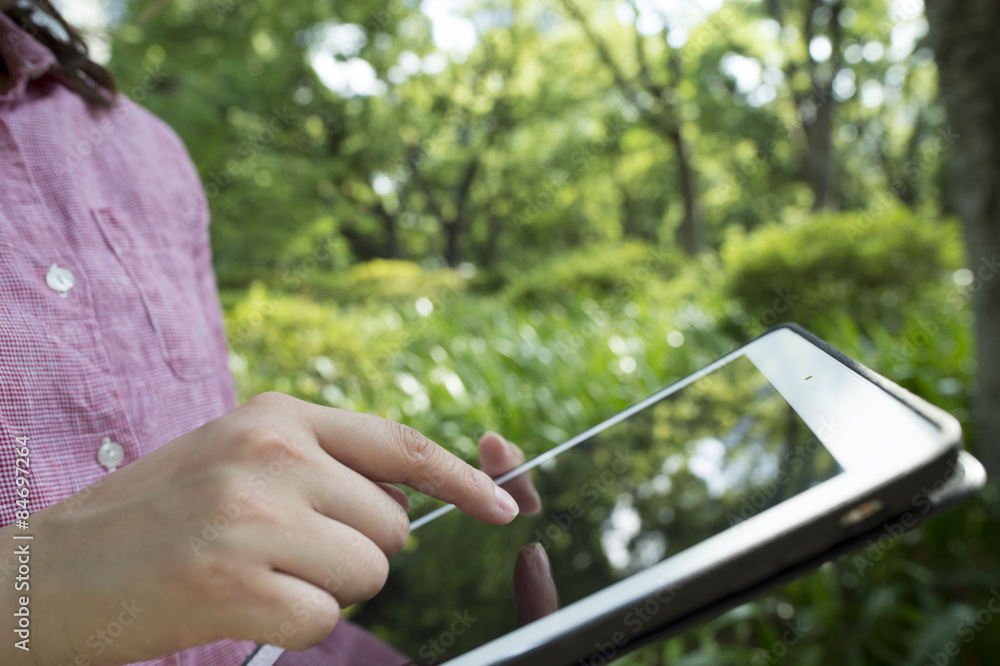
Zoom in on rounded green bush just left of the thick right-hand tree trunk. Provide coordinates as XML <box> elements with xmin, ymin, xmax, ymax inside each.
<box><xmin>721</xmin><ymin>208</ymin><xmax>962</xmax><ymax>334</ymax></box>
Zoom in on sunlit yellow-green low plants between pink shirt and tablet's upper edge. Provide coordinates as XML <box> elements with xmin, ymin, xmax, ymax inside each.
<box><xmin>228</xmin><ymin>260</ymin><xmax>729</xmax><ymax>460</ymax></box>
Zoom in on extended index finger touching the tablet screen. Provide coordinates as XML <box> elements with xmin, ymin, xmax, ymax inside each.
<box><xmin>302</xmin><ymin>403</ymin><xmax>518</xmax><ymax>525</ymax></box>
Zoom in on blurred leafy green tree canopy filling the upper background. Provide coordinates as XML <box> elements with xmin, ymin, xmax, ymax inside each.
<box><xmin>110</xmin><ymin>0</ymin><xmax>947</xmax><ymax>288</ymax></box>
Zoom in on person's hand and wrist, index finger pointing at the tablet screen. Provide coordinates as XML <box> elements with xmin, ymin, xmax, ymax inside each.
<box><xmin>0</xmin><ymin>393</ymin><xmax>524</xmax><ymax>665</ymax></box>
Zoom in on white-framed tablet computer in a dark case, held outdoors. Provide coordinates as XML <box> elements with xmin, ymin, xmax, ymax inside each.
<box><xmin>256</xmin><ymin>325</ymin><xmax>985</xmax><ymax>666</ymax></box>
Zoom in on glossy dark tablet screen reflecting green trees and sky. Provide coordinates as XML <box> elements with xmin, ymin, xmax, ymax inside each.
<box><xmin>349</xmin><ymin>355</ymin><xmax>841</xmax><ymax>660</ymax></box>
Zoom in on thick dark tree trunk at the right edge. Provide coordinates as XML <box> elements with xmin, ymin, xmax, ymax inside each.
<box><xmin>927</xmin><ymin>0</ymin><xmax>1000</xmax><ymax>474</ymax></box>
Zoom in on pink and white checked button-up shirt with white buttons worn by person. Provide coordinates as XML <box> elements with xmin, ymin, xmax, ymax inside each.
<box><xmin>0</xmin><ymin>13</ymin><xmax>403</xmax><ymax>666</ymax></box>
